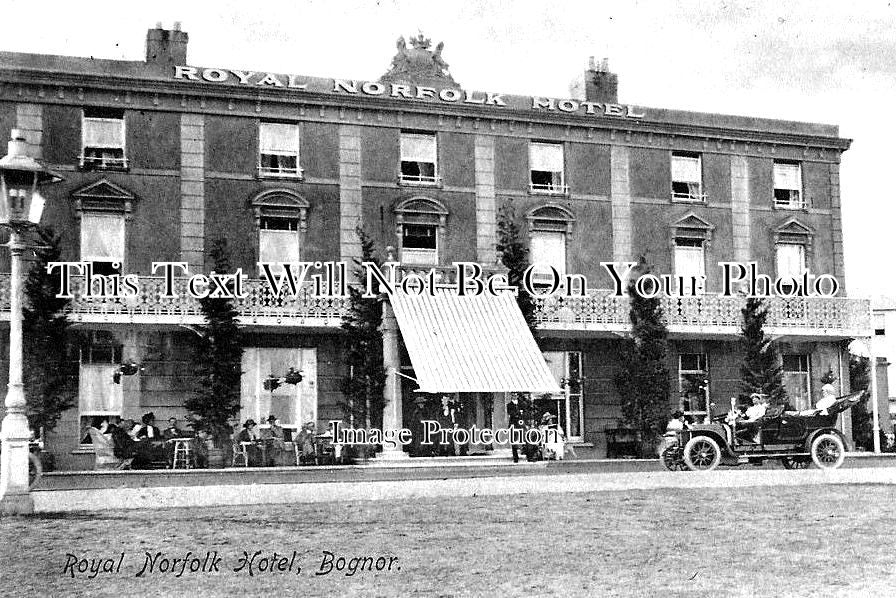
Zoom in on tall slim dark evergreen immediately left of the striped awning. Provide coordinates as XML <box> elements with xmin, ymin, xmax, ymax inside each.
<box><xmin>339</xmin><ymin>227</ymin><xmax>386</xmax><ymax>428</ymax></box>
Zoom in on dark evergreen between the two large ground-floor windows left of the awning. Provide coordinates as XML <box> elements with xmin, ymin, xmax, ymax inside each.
<box><xmin>184</xmin><ymin>239</ymin><xmax>243</xmax><ymax>448</ymax></box>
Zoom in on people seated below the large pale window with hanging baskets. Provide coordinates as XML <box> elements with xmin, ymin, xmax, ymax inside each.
<box><xmin>232</xmin><ymin>415</ymin><xmax>317</xmax><ymax>467</ymax></box>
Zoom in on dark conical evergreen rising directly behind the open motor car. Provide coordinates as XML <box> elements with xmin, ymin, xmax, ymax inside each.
<box><xmin>740</xmin><ymin>297</ymin><xmax>787</xmax><ymax>405</ymax></box>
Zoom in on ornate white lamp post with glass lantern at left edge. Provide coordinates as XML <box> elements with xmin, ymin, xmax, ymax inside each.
<box><xmin>0</xmin><ymin>129</ymin><xmax>62</xmax><ymax>514</ymax></box>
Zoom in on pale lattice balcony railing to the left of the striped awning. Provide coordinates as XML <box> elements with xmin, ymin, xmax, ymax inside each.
<box><xmin>0</xmin><ymin>274</ymin><xmax>348</xmax><ymax>329</ymax></box>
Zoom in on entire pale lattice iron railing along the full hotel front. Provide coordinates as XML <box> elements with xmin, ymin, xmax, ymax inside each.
<box><xmin>0</xmin><ymin>276</ymin><xmax>872</xmax><ymax>338</ymax></box>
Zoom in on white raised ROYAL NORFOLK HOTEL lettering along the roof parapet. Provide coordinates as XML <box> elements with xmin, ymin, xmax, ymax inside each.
<box><xmin>174</xmin><ymin>66</ymin><xmax>644</xmax><ymax>119</ymax></box>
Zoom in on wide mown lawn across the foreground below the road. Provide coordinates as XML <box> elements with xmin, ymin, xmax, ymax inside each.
<box><xmin>0</xmin><ymin>485</ymin><xmax>896</xmax><ymax>597</ymax></box>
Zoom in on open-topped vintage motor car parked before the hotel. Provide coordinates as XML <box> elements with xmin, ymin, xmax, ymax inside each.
<box><xmin>660</xmin><ymin>391</ymin><xmax>866</xmax><ymax>471</ymax></box>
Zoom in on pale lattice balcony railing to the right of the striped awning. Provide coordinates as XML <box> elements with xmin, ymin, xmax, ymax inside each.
<box><xmin>535</xmin><ymin>290</ymin><xmax>871</xmax><ymax>340</ymax></box>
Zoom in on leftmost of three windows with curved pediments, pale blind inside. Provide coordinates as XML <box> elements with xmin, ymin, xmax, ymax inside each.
<box><xmin>250</xmin><ymin>189</ymin><xmax>310</xmax><ymax>273</ymax></box>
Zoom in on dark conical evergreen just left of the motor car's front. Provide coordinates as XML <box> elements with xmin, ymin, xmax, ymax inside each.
<box><xmin>614</xmin><ymin>256</ymin><xmax>670</xmax><ymax>439</ymax></box>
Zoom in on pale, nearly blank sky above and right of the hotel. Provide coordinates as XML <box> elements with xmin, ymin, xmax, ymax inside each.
<box><xmin>0</xmin><ymin>0</ymin><xmax>896</xmax><ymax>296</ymax></box>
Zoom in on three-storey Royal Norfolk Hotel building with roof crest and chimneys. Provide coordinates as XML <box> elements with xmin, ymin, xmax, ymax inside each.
<box><xmin>0</xmin><ymin>25</ymin><xmax>870</xmax><ymax>469</ymax></box>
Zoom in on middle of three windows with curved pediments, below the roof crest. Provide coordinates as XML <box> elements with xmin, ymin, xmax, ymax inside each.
<box><xmin>395</xmin><ymin>197</ymin><xmax>448</xmax><ymax>266</ymax></box>
